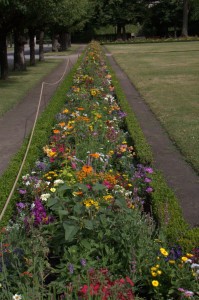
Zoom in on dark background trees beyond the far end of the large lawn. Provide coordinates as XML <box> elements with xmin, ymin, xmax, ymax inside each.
<box><xmin>88</xmin><ymin>0</ymin><xmax>199</xmax><ymax>39</ymax></box>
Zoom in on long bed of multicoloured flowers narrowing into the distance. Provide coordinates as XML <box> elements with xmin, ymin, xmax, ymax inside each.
<box><xmin>0</xmin><ymin>43</ymin><xmax>199</xmax><ymax>300</ymax></box>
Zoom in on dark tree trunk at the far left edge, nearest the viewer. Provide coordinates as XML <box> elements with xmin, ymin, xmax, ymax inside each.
<box><xmin>0</xmin><ymin>30</ymin><xmax>8</xmax><ymax>80</ymax></box>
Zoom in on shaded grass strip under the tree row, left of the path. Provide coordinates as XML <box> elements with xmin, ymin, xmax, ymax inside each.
<box><xmin>0</xmin><ymin>59</ymin><xmax>61</xmax><ymax>117</ymax></box>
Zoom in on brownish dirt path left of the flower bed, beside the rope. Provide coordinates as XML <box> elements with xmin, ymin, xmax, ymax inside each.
<box><xmin>0</xmin><ymin>45</ymin><xmax>85</xmax><ymax>176</ymax></box>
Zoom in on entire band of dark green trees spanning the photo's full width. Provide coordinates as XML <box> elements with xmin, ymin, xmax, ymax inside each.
<box><xmin>0</xmin><ymin>0</ymin><xmax>199</xmax><ymax>79</ymax></box>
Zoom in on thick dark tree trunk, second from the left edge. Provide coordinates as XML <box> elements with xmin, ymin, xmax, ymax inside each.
<box><xmin>14</xmin><ymin>31</ymin><xmax>26</xmax><ymax>71</ymax></box>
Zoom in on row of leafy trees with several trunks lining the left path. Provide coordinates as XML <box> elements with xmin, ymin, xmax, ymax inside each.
<box><xmin>0</xmin><ymin>0</ymin><xmax>91</xmax><ymax>79</ymax></box>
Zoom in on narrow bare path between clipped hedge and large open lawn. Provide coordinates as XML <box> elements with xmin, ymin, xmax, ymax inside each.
<box><xmin>106</xmin><ymin>50</ymin><xmax>199</xmax><ymax>227</ymax></box>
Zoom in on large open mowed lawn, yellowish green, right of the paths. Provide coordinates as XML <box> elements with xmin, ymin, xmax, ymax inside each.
<box><xmin>107</xmin><ymin>42</ymin><xmax>199</xmax><ymax>173</ymax></box>
